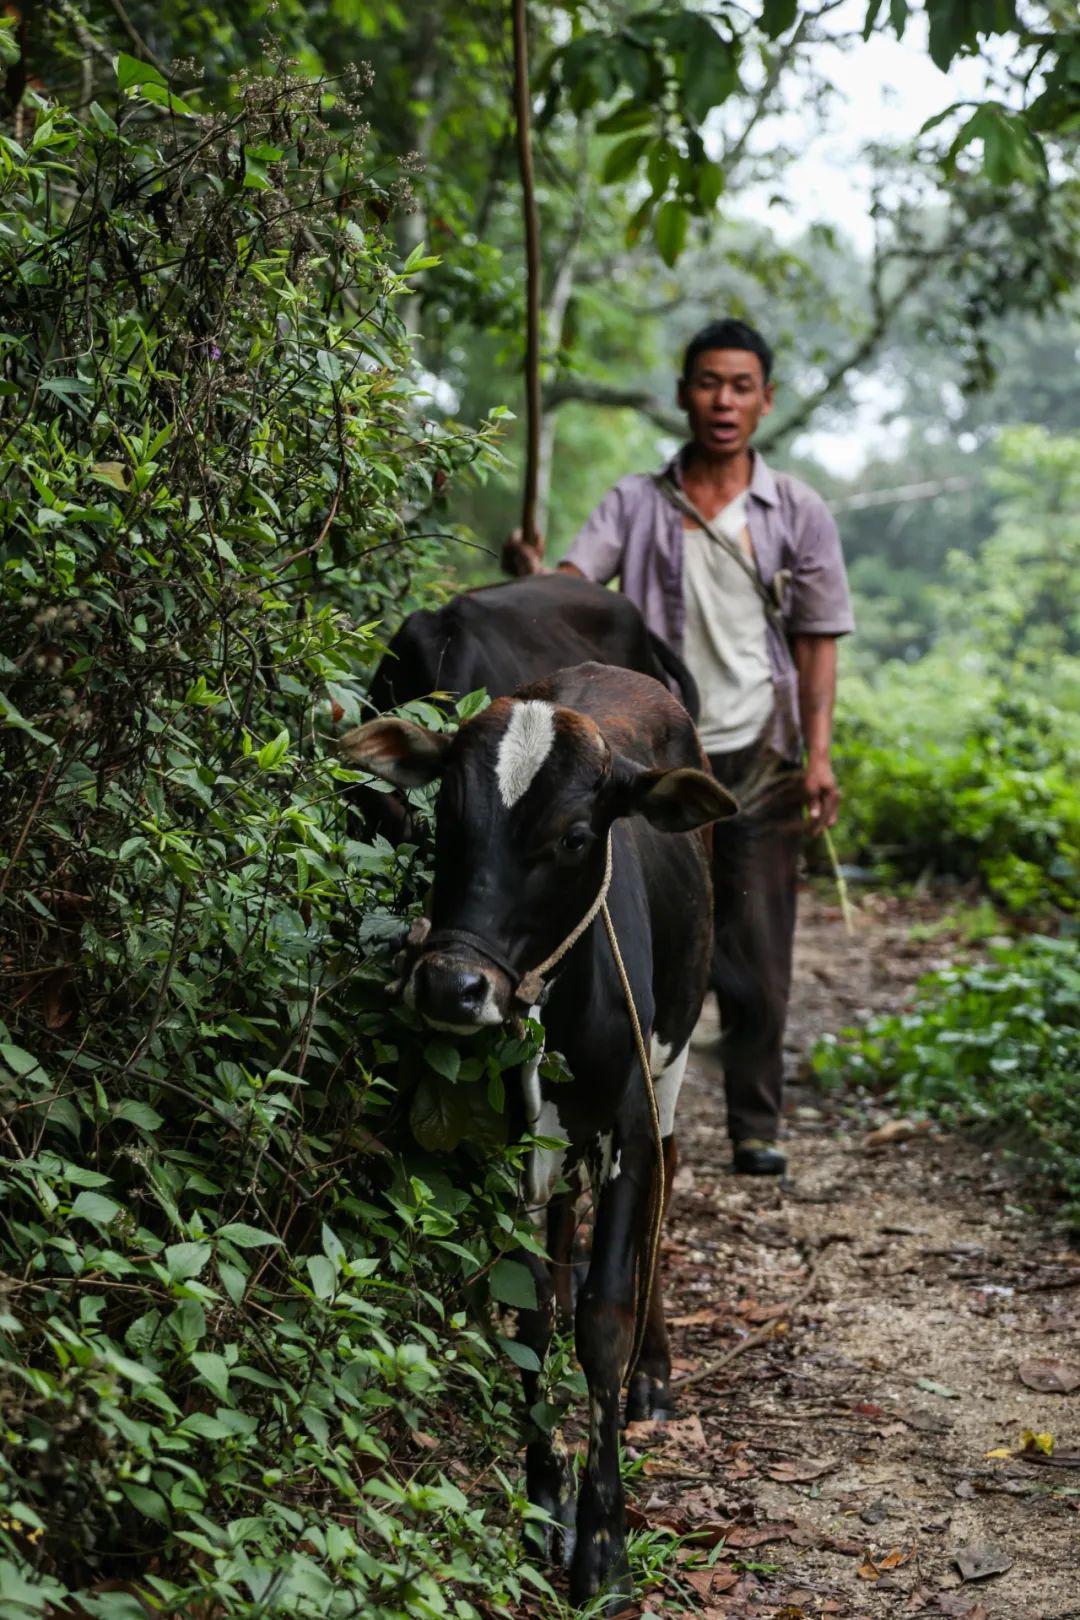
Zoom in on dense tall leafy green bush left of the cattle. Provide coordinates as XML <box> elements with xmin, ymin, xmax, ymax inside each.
<box><xmin>0</xmin><ymin>55</ymin><xmax>553</xmax><ymax>1620</ymax></box>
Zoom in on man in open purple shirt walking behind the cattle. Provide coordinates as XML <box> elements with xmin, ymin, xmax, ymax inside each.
<box><xmin>508</xmin><ymin>319</ymin><xmax>853</xmax><ymax>1176</ymax></box>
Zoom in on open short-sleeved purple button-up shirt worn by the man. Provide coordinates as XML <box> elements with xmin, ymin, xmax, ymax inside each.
<box><xmin>562</xmin><ymin>449</ymin><xmax>855</xmax><ymax>758</ymax></box>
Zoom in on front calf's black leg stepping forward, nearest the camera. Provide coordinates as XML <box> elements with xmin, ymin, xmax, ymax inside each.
<box><xmin>570</xmin><ymin>1128</ymin><xmax>653</xmax><ymax>1614</ymax></box>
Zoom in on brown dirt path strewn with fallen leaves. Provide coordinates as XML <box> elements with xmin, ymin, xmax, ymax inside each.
<box><xmin>628</xmin><ymin>899</ymin><xmax>1080</xmax><ymax>1620</ymax></box>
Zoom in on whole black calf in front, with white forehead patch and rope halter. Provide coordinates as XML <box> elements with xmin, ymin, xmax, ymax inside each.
<box><xmin>343</xmin><ymin>663</ymin><xmax>733</xmax><ymax>1602</ymax></box>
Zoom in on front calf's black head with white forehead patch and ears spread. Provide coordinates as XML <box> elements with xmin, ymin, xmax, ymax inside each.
<box><xmin>342</xmin><ymin>698</ymin><xmax>735</xmax><ymax>1034</ymax></box>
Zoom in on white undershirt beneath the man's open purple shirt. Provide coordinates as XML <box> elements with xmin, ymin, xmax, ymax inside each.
<box><xmin>683</xmin><ymin>492</ymin><xmax>772</xmax><ymax>753</ymax></box>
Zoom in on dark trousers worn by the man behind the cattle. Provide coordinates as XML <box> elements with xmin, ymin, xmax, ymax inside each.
<box><xmin>709</xmin><ymin>742</ymin><xmax>803</xmax><ymax>1142</ymax></box>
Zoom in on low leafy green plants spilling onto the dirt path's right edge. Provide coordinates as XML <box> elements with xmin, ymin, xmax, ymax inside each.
<box><xmin>813</xmin><ymin>936</ymin><xmax>1080</xmax><ymax>1209</ymax></box>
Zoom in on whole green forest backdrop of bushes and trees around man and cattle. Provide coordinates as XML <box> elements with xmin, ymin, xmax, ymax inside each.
<box><xmin>0</xmin><ymin>0</ymin><xmax>1080</xmax><ymax>1620</ymax></box>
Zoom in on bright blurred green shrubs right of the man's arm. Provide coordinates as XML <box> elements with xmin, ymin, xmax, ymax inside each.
<box><xmin>837</xmin><ymin>428</ymin><xmax>1080</xmax><ymax>912</ymax></box>
